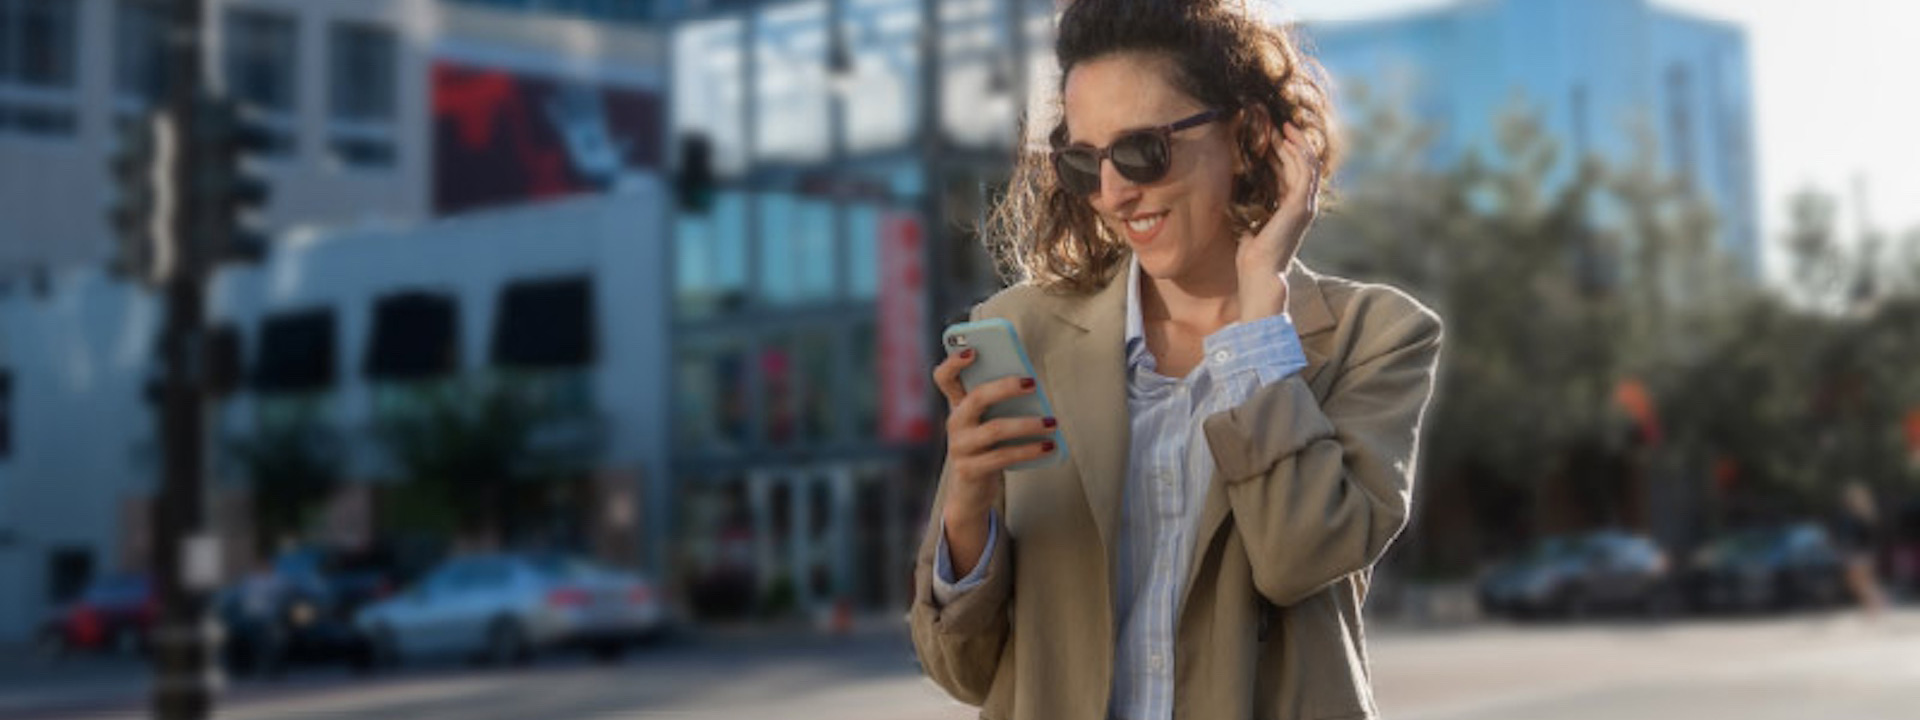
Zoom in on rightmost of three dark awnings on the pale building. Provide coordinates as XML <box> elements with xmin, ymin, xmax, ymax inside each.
<box><xmin>492</xmin><ymin>275</ymin><xmax>597</xmax><ymax>367</ymax></box>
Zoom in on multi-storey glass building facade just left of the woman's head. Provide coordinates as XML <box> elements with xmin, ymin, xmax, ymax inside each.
<box><xmin>668</xmin><ymin>0</ymin><xmax>1046</xmax><ymax>616</ymax></box>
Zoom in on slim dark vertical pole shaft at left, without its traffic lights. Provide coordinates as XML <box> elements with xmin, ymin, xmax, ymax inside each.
<box><xmin>150</xmin><ymin>0</ymin><xmax>221</xmax><ymax>720</ymax></box>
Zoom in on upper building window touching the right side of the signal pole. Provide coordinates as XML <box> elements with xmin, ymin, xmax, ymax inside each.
<box><xmin>225</xmin><ymin>10</ymin><xmax>300</xmax><ymax>156</ymax></box>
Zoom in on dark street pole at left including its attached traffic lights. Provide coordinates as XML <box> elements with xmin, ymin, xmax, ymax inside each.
<box><xmin>108</xmin><ymin>0</ymin><xmax>271</xmax><ymax>720</ymax></box>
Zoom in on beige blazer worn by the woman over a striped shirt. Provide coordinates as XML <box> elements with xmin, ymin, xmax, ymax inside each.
<box><xmin>908</xmin><ymin>263</ymin><xmax>1440</xmax><ymax>720</ymax></box>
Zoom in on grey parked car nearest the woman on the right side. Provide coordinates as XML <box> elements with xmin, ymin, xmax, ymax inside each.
<box><xmin>1480</xmin><ymin>530</ymin><xmax>1678</xmax><ymax>618</ymax></box>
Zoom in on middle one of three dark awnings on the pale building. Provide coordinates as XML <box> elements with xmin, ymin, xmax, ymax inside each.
<box><xmin>361</xmin><ymin>292</ymin><xmax>461</xmax><ymax>380</ymax></box>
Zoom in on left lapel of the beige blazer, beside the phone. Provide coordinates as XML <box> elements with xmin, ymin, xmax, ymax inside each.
<box><xmin>1044</xmin><ymin>271</ymin><xmax>1131</xmax><ymax>559</ymax></box>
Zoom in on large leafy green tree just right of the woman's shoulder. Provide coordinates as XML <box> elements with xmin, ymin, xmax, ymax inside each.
<box><xmin>1306</xmin><ymin>93</ymin><xmax>1747</xmax><ymax>574</ymax></box>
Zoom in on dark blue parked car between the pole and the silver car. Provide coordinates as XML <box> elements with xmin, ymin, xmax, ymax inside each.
<box><xmin>217</xmin><ymin>547</ymin><xmax>392</xmax><ymax>674</ymax></box>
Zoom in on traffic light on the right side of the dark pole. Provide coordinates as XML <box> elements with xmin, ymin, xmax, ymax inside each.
<box><xmin>192</xmin><ymin>96</ymin><xmax>273</xmax><ymax>265</ymax></box>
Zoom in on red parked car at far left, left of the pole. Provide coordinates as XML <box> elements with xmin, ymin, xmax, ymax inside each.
<box><xmin>36</xmin><ymin>572</ymin><xmax>159</xmax><ymax>655</ymax></box>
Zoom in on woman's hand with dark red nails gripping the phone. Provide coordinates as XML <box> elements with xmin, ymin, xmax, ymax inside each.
<box><xmin>933</xmin><ymin>349</ymin><xmax>1056</xmax><ymax>576</ymax></box>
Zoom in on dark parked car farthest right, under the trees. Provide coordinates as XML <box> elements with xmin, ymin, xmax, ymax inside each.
<box><xmin>1686</xmin><ymin>522</ymin><xmax>1845</xmax><ymax>611</ymax></box>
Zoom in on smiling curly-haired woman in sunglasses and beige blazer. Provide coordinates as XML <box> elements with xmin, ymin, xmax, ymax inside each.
<box><xmin>910</xmin><ymin>0</ymin><xmax>1440</xmax><ymax>720</ymax></box>
